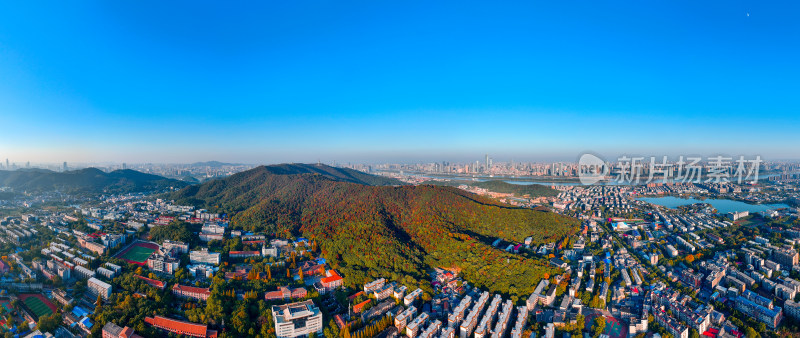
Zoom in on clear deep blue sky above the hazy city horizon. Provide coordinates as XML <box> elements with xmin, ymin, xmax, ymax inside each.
<box><xmin>0</xmin><ymin>0</ymin><xmax>800</xmax><ymax>163</ymax></box>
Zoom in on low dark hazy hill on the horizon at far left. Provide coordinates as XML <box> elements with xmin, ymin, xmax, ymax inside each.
<box><xmin>0</xmin><ymin>168</ymin><xmax>188</xmax><ymax>193</ymax></box>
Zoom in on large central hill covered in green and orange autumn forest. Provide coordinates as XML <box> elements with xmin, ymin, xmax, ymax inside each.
<box><xmin>171</xmin><ymin>167</ymin><xmax>578</xmax><ymax>297</ymax></box>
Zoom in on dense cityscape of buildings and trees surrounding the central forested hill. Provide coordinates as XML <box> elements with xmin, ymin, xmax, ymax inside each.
<box><xmin>0</xmin><ymin>158</ymin><xmax>800</xmax><ymax>338</ymax></box>
